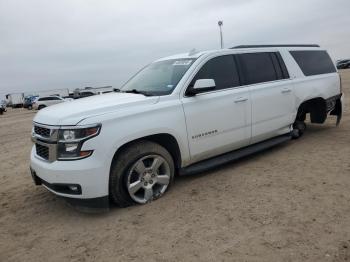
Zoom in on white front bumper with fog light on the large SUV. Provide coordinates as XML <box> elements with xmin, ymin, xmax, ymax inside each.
<box><xmin>30</xmin><ymin>145</ymin><xmax>109</xmax><ymax>199</ymax></box>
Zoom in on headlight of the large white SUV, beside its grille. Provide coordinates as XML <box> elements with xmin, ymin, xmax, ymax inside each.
<box><xmin>57</xmin><ymin>124</ymin><xmax>101</xmax><ymax>160</ymax></box>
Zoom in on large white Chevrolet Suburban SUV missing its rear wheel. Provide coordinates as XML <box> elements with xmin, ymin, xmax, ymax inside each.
<box><xmin>31</xmin><ymin>45</ymin><xmax>342</xmax><ymax>207</ymax></box>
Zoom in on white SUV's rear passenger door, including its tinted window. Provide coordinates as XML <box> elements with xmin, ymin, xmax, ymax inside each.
<box><xmin>238</xmin><ymin>52</ymin><xmax>295</xmax><ymax>143</ymax></box>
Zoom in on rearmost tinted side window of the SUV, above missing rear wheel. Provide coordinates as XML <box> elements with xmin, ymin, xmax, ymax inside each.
<box><xmin>290</xmin><ymin>50</ymin><xmax>336</xmax><ymax>76</ymax></box>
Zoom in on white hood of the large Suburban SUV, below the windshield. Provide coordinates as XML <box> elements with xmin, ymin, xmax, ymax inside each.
<box><xmin>33</xmin><ymin>93</ymin><xmax>159</xmax><ymax>125</ymax></box>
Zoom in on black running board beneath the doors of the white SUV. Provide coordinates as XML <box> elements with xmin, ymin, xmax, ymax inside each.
<box><xmin>179</xmin><ymin>134</ymin><xmax>291</xmax><ymax>176</ymax></box>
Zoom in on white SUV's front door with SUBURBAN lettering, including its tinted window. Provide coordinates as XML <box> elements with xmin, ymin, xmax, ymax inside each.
<box><xmin>182</xmin><ymin>55</ymin><xmax>251</xmax><ymax>162</ymax></box>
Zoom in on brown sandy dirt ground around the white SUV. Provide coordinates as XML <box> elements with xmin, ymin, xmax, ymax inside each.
<box><xmin>0</xmin><ymin>70</ymin><xmax>350</xmax><ymax>262</ymax></box>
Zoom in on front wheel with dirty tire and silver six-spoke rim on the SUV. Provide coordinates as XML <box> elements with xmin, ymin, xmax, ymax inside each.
<box><xmin>109</xmin><ymin>141</ymin><xmax>175</xmax><ymax>207</ymax></box>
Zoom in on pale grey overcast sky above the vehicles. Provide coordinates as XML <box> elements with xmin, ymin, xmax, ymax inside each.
<box><xmin>0</xmin><ymin>0</ymin><xmax>350</xmax><ymax>99</ymax></box>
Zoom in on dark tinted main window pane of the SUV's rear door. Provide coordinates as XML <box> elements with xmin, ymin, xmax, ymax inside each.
<box><xmin>238</xmin><ymin>53</ymin><xmax>283</xmax><ymax>85</ymax></box>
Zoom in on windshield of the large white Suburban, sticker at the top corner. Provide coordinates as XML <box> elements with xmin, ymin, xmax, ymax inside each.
<box><xmin>121</xmin><ymin>59</ymin><xmax>195</xmax><ymax>96</ymax></box>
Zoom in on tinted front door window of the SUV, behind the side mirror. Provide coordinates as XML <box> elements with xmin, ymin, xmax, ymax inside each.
<box><xmin>190</xmin><ymin>55</ymin><xmax>239</xmax><ymax>90</ymax></box>
